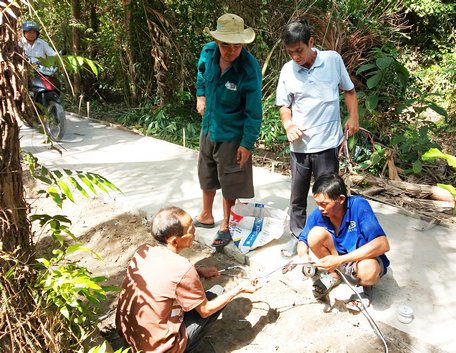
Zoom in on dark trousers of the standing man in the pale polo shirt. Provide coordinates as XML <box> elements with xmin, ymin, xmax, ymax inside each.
<box><xmin>290</xmin><ymin>148</ymin><xmax>339</xmax><ymax>237</ymax></box>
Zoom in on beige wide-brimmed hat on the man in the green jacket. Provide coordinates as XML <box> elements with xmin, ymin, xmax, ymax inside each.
<box><xmin>209</xmin><ymin>13</ymin><xmax>255</xmax><ymax>44</ymax></box>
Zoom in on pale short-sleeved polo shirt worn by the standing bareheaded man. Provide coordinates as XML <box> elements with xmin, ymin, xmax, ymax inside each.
<box><xmin>276</xmin><ymin>49</ymin><xmax>354</xmax><ymax>153</ymax></box>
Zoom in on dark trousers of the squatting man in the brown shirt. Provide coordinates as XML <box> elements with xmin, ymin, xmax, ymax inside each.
<box><xmin>184</xmin><ymin>291</ymin><xmax>224</xmax><ymax>353</ymax></box>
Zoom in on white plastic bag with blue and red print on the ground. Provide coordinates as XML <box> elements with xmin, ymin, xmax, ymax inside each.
<box><xmin>230</xmin><ymin>202</ymin><xmax>287</xmax><ymax>254</ymax></box>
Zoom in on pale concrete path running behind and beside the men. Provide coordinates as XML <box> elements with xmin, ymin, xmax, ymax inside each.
<box><xmin>21</xmin><ymin>114</ymin><xmax>456</xmax><ymax>352</ymax></box>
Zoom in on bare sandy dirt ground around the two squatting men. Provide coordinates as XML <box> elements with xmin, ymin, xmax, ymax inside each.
<box><xmin>28</xmin><ymin>179</ymin><xmax>433</xmax><ymax>353</ymax></box>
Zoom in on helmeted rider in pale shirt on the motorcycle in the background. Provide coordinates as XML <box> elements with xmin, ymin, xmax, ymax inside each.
<box><xmin>19</xmin><ymin>21</ymin><xmax>57</xmax><ymax>64</ymax></box>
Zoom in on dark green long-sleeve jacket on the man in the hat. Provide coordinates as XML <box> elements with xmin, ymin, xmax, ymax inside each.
<box><xmin>196</xmin><ymin>42</ymin><xmax>262</xmax><ymax>150</ymax></box>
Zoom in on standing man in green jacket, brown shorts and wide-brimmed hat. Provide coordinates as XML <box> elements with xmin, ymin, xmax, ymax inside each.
<box><xmin>194</xmin><ymin>14</ymin><xmax>262</xmax><ymax>247</ymax></box>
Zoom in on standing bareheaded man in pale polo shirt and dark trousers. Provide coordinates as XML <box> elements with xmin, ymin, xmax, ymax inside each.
<box><xmin>276</xmin><ymin>20</ymin><xmax>359</xmax><ymax>256</ymax></box>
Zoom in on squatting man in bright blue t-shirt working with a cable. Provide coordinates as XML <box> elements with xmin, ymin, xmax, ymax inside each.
<box><xmin>297</xmin><ymin>174</ymin><xmax>390</xmax><ymax>310</ymax></box>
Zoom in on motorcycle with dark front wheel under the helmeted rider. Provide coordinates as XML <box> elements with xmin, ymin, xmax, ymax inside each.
<box><xmin>29</xmin><ymin>64</ymin><xmax>65</xmax><ymax>142</ymax></box>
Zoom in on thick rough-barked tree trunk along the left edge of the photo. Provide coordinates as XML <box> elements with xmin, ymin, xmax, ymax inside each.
<box><xmin>0</xmin><ymin>16</ymin><xmax>32</xmax><ymax>256</ymax></box>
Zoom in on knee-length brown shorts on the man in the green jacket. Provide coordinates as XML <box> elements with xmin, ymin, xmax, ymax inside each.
<box><xmin>198</xmin><ymin>133</ymin><xmax>254</xmax><ymax>200</ymax></box>
